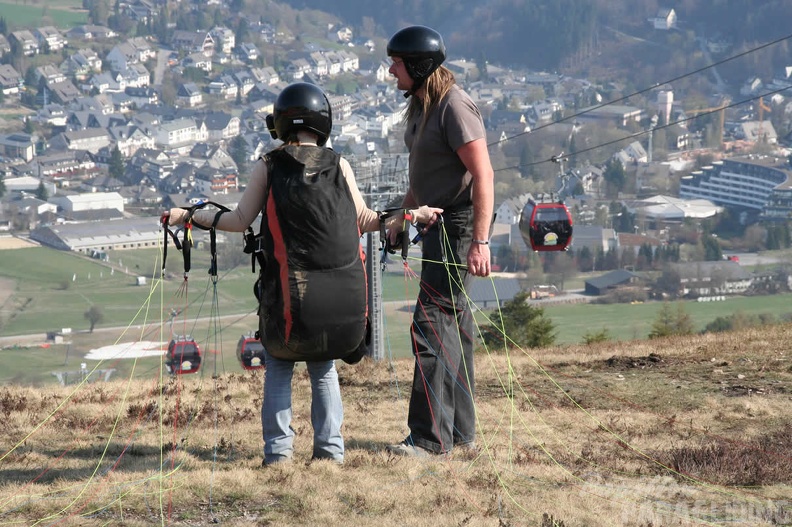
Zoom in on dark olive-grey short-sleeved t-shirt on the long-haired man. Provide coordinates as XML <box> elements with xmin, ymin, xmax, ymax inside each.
<box><xmin>404</xmin><ymin>85</ymin><xmax>486</xmax><ymax>209</ymax></box>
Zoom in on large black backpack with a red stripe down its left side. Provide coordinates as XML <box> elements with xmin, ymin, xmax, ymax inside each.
<box><xmin>245</xmin><ymin>145</ymin><xmax>371</xmax><ymax>363</ymax></box>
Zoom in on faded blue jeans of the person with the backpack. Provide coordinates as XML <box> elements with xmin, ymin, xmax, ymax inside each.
<box><xmin>261</xmin><ymin>353</ymin><xmax>344</xmax><ymax>464</ymax></box>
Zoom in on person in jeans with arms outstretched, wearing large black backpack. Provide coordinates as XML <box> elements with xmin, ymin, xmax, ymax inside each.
<box><xmin>168</xmin><ymin>83</ymin><xmax>442</xmax><ymax>465</ymax></box>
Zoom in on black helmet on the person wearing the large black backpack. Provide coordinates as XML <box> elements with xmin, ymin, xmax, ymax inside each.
<box><xmin>267</xmin><ymin>82</ymin><xmax>333</xmax><ymax>146</ymax></box>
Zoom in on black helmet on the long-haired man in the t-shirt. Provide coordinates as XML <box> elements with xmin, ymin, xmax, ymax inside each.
<box><xmin>388</xmin><ymin>26</ymin><xmax>445</xmax><ymax>87</ymax></box>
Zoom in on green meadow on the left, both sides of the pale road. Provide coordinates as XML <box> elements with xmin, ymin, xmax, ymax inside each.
<box><xmin>0</xmin><ymin>246</ymin><xmax>417</xmax><ymax>385</ymax></box>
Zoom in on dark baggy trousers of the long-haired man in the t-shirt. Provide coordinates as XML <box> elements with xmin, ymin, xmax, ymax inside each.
<box><xmin>407</xmin><ymin>208</ymin><xmax>476</xmax><ymax>454</ymax></box>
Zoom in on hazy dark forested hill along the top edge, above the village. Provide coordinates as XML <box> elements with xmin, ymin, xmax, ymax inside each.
<box><xmin>290</xmin><ymin>0</ymin><xmax>792</xmax><ymax>70</ymax></box>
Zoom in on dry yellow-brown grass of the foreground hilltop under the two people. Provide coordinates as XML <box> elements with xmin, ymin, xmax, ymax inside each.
<box><xmin>0</xmin><ymin>326</ymin><xmax>792</xmax><ymax>527</ymax></box>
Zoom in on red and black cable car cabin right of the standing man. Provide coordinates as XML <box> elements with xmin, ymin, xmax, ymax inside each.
<box><xmin>520</xmin><ymin>195</ymin><xmax>572</xmax><ymax>251</ymax></box>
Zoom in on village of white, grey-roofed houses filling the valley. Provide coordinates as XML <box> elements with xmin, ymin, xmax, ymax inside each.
<box><xmin>0</xmin><ymin>4</ymin><xmax>792</xmax><ymax>308</ymax></box>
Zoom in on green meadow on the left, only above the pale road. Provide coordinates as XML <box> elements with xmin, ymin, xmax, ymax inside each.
<box><xmin>0</xmin><ymin>247</ymin><xmax>417</xmax><ymax>335</ymax></box>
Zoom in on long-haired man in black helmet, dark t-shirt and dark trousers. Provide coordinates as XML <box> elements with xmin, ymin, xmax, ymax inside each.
<box><xmin>387</xmin><ymin>26</ymin><xmax>494</xmax><ymax>456</ymax></box>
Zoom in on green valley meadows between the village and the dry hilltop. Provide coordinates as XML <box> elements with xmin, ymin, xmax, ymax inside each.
<box><xmin>0</xmin><ymin>247</ymin><xmax>792</xmax><ymax>384</ymax></box>
